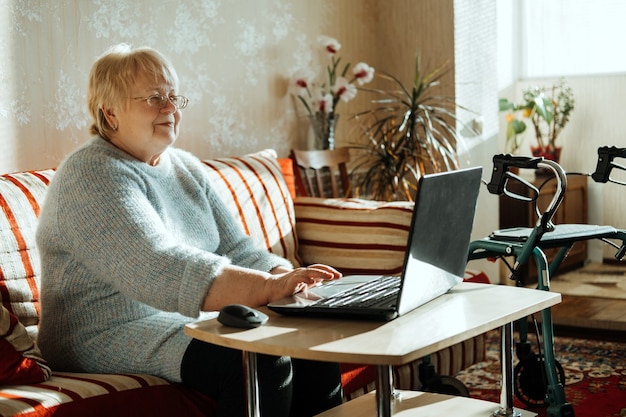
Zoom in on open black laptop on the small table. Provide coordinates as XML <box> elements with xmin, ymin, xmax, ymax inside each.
<box><xmin>268</xmin><ymin>167</ymin><xmax>482</xmax><ymax>321</ymax></box>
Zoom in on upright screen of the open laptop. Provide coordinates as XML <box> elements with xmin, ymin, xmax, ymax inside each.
<box><xmin>398</xmin><ymin>167</ymin><xmax>482</xmax><ymax>315</ymax></box>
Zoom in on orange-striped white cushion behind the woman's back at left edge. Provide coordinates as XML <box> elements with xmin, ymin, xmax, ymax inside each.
<box><xmin>0</xmin><ymin>170</ymin><xmax>54</xmax><ymax>326</ymax></box>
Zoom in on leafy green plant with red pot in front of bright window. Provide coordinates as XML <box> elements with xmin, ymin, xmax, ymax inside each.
<box><xmin>499</xmin><ymin>78</ymin><xmax>574</xmax><ymax>162</ymax></box>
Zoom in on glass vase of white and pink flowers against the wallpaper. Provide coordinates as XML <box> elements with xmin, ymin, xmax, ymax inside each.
<box><xmin>290</xmin><ymin>36</ymin><xmax>374</xmax><ymax>149</ymax></box>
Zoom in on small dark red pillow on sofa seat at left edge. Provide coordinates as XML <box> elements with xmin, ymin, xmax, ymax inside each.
<box><xmin>0</xmin><ymin>306</ymin><xmax>51</xmax><ymax>385</ymax></box>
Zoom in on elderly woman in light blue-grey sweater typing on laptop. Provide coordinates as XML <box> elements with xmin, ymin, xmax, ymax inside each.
<box><xmin>37</xmin><ymin>45</ymin><xmax>341</xmax><ymax>417</ymax></box>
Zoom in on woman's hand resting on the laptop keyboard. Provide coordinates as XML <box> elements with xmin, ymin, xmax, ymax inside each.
<box><xmin>265</xmin><ymin>264</ymin><xmax>341</xmax><ymax>303</ymax></box>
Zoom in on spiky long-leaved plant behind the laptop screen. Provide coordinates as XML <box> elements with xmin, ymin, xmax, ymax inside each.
<box><xmin>351</xmin><ymin>54</ymin><xmax>463</xmax><ymax>201</ymax></box>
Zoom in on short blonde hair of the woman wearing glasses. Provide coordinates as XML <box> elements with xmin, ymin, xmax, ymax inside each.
<box><xmin>87</xmin><ymin>43</ymin><xmax>178</xmax><ymax>140</ymax></box>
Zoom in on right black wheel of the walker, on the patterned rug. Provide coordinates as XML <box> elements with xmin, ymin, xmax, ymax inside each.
<box><xmin>514</xmin><ymin>355</ymin><xmax>565</xmax><ymax>407</ymax></box>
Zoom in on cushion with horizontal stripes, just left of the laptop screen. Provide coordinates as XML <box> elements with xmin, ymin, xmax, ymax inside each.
<box><xmin>294</xmin><ymin>197</ymin><xmax>413</xmax><ymax>274</ymax></box>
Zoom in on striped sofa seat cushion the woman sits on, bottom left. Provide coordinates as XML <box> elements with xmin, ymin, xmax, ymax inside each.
<box><xmin>0</xmin><ymin>372</ymin><xmax>215</xmax><ymax>417</ymax></box>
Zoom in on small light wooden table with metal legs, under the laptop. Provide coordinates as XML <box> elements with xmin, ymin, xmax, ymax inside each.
<box><xmin>186</xmin><ymin>283</ymin><xmax>561</xmax><ymax>417</ymax></box>
